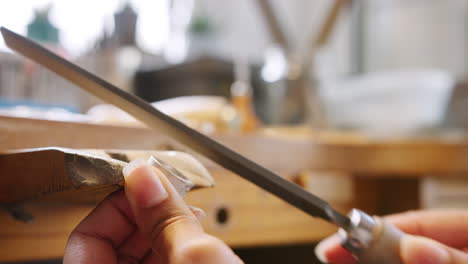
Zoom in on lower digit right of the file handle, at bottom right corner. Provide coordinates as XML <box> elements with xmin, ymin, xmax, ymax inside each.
<box><xmin>400</xmin><ymin>235</ymin><xmax>468</xmax><ymax>264</ymax></box>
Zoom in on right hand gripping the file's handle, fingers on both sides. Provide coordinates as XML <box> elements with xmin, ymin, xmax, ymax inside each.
<box><xmin>315</xmin><ymin>210</ymin><xmax>468</xmax><ymax>264</ymax></box>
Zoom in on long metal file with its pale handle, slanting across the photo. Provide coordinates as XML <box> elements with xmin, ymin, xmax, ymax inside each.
<box><xmin>0</xmin><ymin>27</ymin><xmax>400</xmax><ymax>263</ymax></box>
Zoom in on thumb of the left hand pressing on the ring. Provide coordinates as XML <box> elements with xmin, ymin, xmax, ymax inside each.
<box><xmin>124</xmin><ymin>164</ymin><xmax>239</xmax><ymax>264</ymax></box>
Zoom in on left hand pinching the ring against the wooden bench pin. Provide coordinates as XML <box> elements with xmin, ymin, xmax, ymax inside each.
<box><xmin>63</xmin><ymin>165</ymin><xmax>242</xmax><ymax>264</ymax></box>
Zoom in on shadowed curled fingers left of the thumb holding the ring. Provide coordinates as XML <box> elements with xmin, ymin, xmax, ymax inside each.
<box><xmin>64</xmin><ymin>191</ymin><xmax>135</xmax><ymax>263</ymax></box>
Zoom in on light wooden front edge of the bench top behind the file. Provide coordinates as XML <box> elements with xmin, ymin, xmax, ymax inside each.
<box><xmin>0</xmin><ymin>116</ymin><xmax>468</xmax><ymax>176</ymax></box>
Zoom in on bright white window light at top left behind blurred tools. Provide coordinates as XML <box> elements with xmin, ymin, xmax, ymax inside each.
<box><xmin>0</xmin><ymin>0</ymin><xmax>169</xmax><ymax>56</ymax></box>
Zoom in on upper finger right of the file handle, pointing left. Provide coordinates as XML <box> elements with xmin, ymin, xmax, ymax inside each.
<box><xmin>386</xmin><ymin>210</ymin><xmax>468</xmax><ymax>248</ymax></box>
